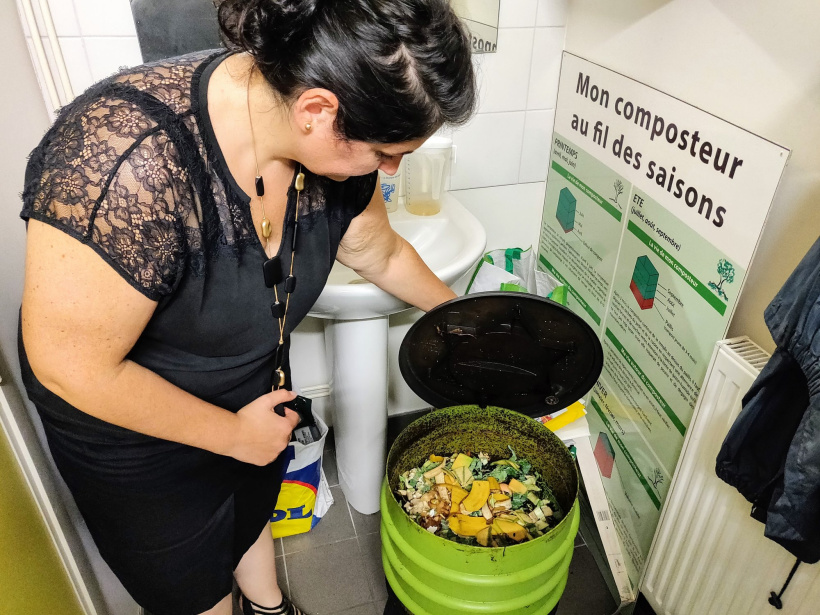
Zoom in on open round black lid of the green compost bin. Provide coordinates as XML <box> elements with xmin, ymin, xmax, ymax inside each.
<box><xmin>399</xmin><ymin>292</ymin><xmax>603</xmax><ymax>417</ymax></box>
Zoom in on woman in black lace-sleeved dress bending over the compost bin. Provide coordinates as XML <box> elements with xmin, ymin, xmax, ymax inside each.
<box><xmin>20</xmin><ymin>0</ymin><xmax>475</xmax><ymax>615</ymax></box>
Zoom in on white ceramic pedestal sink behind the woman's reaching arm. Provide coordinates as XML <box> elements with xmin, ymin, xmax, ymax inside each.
<box><xmin>310</xmin><ymin>193</ymin><xmax>487</xmax><ymax>514</ymax></box>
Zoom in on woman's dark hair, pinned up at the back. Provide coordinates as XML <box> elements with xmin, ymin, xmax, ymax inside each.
<box><xmin>217</xmin><ymin>0</ymin><xmax>476</xmax><ymax>143</ymax></box>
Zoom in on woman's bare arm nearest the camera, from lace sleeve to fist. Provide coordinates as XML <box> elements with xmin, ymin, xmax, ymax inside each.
<box><xmin>22</xmin><ymin>220</ymin><xmax>298</xmax><ymax>465</ymax></box>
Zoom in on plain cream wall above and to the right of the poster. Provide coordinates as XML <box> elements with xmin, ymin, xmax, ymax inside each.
<box><xmin>566</xmin><ymin>0</ymin><xmax>820</xmax><ymax>351</ymax></box>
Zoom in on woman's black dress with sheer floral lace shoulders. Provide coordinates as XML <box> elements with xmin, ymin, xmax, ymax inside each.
<box><xmin>19</xmin><ymin>52</ymin><xmax>376</xmax><ymax>615</ymax></box>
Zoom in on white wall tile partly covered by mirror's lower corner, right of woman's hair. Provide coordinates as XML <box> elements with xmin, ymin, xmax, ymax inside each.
<box><xmin>473</xmin><ymin>28</ymin><xmax>535</xmax><ymax>113</ymax></box>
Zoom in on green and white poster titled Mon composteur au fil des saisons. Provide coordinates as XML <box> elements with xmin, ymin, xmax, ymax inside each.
<box><xmin>538</xmin><ymin>53</ymin><xmax>789</xmax><ymax>587</ymax></box>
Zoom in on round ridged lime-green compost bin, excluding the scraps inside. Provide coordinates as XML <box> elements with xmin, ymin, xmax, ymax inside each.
<box><xmin>381</xmin><ymin>406</ymin><xmax>580</xmax><ymax>615</ymax></box>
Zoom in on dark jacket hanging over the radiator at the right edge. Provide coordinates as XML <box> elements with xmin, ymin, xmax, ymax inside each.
<box><xmin>716</xmin><ymin>239</ymin><xmax>820</xmax><ymax>563</ymax></box>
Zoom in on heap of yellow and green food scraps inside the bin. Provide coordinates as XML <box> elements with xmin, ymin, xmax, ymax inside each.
<box><xmin>396</xmin><ymin>448</ymin><xmax>564</xmax><ymax>547</ymax></box>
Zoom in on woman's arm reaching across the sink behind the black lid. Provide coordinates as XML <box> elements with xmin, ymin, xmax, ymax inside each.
<box><xmin>336</xmin><ymin>186</ymin><xmax>456</xmax><ymax>312</ymax></box>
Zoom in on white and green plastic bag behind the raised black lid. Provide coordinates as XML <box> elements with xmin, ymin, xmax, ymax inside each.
<box><xmin>467</xmin><ymin>247</ymin><xmax>567</xmax><ymax>305</ymax></box>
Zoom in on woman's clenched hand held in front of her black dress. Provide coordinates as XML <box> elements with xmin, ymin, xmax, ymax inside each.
<box><xmin>231</xmin><ymin>389</ymin><xmax>299</xmax><ymax>466</ymax></box>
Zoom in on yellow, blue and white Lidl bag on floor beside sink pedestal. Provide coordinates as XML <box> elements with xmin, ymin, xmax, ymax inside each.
<box><xmin>271</xmin><ymin>414</ymin><xmax>333</xmax><ymax>538</ymax></box>
